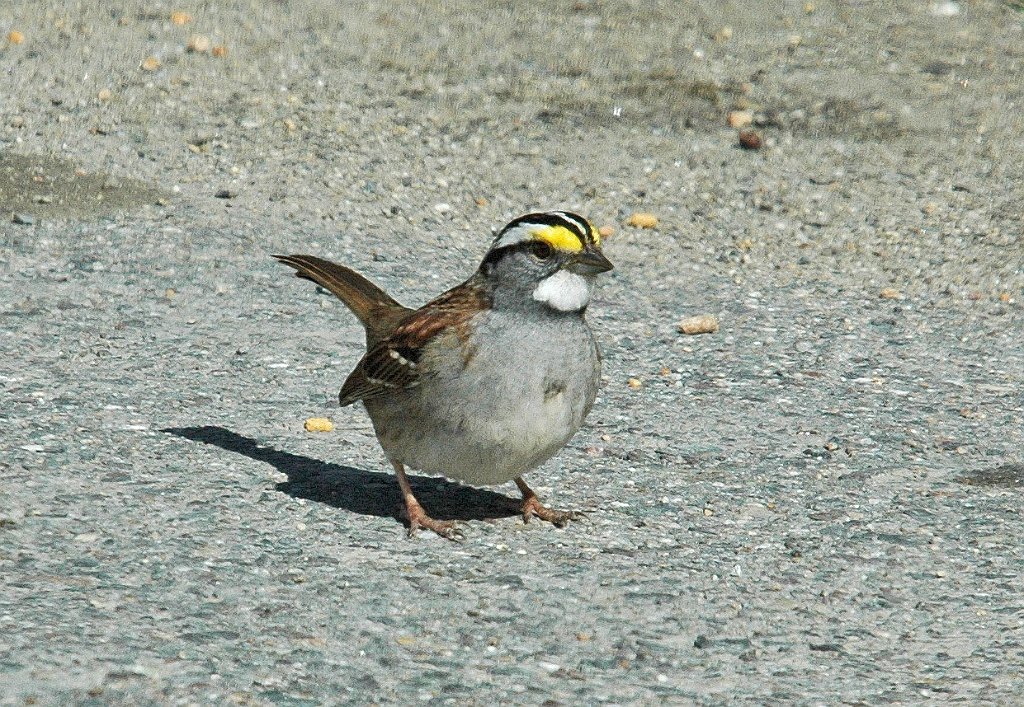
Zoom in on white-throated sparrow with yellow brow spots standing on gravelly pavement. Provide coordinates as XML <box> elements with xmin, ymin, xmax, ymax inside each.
<box><xmin>274</xmin><ymin>211</ymin><xmax>612</xmax><ymax>539</ymax></box>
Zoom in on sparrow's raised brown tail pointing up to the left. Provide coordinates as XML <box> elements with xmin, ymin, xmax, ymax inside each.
<box><xmin>273</xmin><ymin>254</ymin><xmax>412</xmax><ymax>338</ymax></box>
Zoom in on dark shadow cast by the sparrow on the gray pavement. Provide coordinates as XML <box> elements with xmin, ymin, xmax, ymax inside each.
<box><xmin>161</xmin><ymin>425</ymin><xmax>521</xmax><ymax>522</ymax></box>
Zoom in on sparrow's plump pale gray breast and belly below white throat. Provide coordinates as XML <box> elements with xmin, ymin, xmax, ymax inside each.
<box><xmin>366</xmin><ymin>322</ymin><xmax>600</xmax><ymax>485</ymax></box>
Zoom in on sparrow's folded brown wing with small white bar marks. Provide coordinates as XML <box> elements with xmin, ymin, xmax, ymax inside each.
<box><xmin>338</xmin><ymin>281</ymin><xmax>490</xmax><ymax>406</ymax></box>
